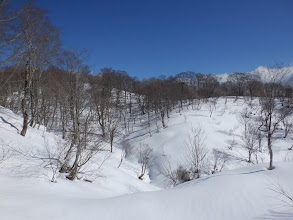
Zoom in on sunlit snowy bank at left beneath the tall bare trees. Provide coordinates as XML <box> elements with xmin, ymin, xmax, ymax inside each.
<box><xmin>0</xmin><ymin>106</ymin><xmax>158</xmax><ymax>198</ymax></box>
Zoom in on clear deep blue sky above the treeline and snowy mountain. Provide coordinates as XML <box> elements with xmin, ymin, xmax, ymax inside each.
<box><xmin>29</xmin><ymin>0</ymin><xmax>293</xmax><ymax>79</ymax></box>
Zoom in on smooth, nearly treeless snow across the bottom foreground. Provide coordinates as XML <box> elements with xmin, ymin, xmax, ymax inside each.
<box><xmin>0</xmin><ymin>163</ymin><xmax>293</xmax><ymax>220</ymax></box>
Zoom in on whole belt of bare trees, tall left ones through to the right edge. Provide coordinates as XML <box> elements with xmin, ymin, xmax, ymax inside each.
<box><xmin>0</xmin><ymin>0</ymin><xmax>292</xmax><ymax>180</ymax></box>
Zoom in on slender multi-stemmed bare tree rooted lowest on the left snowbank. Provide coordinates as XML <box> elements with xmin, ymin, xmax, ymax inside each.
<box><xmin>56</xmin><ymin>49</ymin><xmax>92</xmax><ymax>175</ymax></box>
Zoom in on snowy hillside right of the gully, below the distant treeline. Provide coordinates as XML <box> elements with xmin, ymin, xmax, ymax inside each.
<box><xmin>128</xmin><ymin>97</ymin><xmax>293</xmax><ymax>188</ymax></box>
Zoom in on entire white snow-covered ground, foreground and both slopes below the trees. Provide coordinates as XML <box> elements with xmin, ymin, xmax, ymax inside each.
<box><xmin>0</xmin><ymin>98</ymin><xmax>293</xmax><ymax>220</ymax></box>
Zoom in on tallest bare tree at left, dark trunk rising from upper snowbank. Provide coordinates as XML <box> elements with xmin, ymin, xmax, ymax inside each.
<box><xmin>19</xmin><ymin>3</ymin><xmax>60</xmax><ymax>136</ymax></box>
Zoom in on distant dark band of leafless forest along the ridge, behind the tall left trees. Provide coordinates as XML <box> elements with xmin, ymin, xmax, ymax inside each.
<box><xmin>0</xmin><ymin>62</ymin><xmax>292</xmax><ymax>135</ymax></box>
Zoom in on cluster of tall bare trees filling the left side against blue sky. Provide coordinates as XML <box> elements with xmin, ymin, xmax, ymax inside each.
<box><xmin>0</xmin><ymin>0</ymin><xmax>105</xmax><ymax>180</ymax></box>
